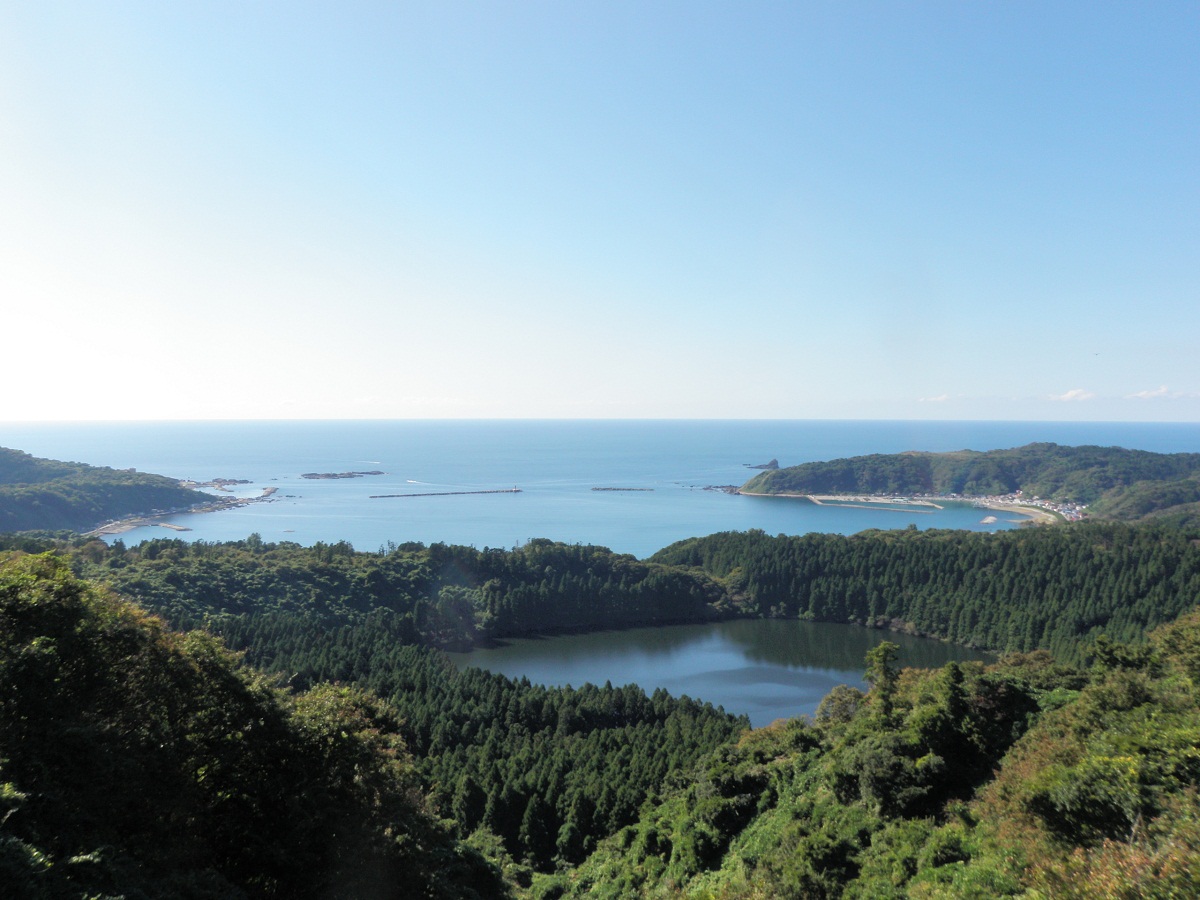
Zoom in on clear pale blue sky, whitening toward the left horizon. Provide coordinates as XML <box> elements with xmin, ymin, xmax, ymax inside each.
<box><xmin>0</xmin><ymin>0</ymin><xmax>1200</xmax><ymax>421</ymax></box>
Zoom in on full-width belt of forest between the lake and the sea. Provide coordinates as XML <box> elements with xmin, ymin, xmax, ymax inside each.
<box><xmin>51</xmin><ymin>522</ymin><xmax>1200</xmax><ymax>662</ymax></box>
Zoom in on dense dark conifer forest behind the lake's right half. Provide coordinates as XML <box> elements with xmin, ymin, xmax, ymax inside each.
<box><xmin>650</xmin><ymin>522</ymin><xmax>1200</xmax><ymax>661</ymax></box>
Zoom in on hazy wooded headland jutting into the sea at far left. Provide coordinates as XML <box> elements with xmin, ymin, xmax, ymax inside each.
<box><xmin>0</xmin><ymin>448</ymin><xmax>204</xmax><ymax>532</ymax></box>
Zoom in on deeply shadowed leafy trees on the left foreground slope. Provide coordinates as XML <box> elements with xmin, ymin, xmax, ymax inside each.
<box><xmin>0</xmin><ymin>557</ymin><xmax>505</xmax><ymax>899</ymax></box>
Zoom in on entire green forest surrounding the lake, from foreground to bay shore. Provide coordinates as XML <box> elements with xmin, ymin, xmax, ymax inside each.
<box><xmin>7</xmin><ymin>513</ymin><xmax>1200</xmax><ymax>898</ymax></box>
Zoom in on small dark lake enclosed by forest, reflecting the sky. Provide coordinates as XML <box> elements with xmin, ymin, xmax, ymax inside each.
<box><xmin>450</xmin><ymin>619</ymin><xmax>988</xmax><ymax>727</ymax></box>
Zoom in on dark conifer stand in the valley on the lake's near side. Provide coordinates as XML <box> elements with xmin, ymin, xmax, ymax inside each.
<box><xmin>222</xmin><ymin>611</ymin><xmax>749</xmax><ymax>869</ymax></box>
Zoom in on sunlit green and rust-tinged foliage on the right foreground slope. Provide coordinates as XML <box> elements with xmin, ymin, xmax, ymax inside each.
<box><xmin>552</xmin><ymin>613</ymin><xmax>1200</xmax><ymax>900</ymax></box>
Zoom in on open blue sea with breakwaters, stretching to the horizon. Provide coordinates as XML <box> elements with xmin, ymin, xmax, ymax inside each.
<box><xmin>0</xmin><ymin>420</ymin><xmax>1200</xmax><ymax>557</ymax></box>
